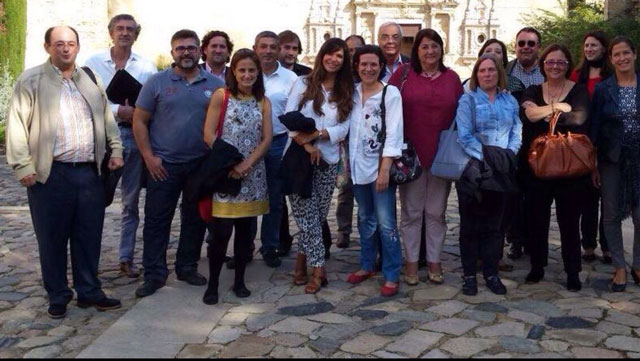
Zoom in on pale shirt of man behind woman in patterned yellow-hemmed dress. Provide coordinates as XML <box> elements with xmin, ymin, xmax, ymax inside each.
<box><xmin>262</xmin><ymin>63</ymin><xmax>298</xmax><ymax>136</ymax></box>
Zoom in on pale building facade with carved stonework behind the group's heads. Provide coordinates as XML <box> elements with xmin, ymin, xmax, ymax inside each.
<box><xmin>26</xmin><ymin>0</ymin><xmax>562</xmax><ymax>75</ymax></box>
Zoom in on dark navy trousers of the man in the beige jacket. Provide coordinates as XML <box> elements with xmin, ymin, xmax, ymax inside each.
<box><xmin>27</xmin><ymin>162</ymin><xmax>105</xmax><ymax>305</ymax></box>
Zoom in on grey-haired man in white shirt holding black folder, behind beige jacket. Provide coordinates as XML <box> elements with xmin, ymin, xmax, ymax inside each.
<box><xmin>85</xmin><ymin>14</ymin><xmax>157</xmax><ymax>278</ymax></box>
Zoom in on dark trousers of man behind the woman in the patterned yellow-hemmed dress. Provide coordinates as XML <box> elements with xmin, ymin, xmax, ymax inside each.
<box><xmin>260</xmin><ymin>133</ymin><xmax>288</xmax><ymax>255</ymax></box>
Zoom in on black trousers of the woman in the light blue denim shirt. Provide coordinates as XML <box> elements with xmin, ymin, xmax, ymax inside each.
<box><xmin>456</xmin><ymin>187</ymin><xmax>508</xmax><ymax>279</ymax></box>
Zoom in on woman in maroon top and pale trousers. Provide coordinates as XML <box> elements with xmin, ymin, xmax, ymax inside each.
<box><xmin>389</xmin><ymin>29</ymin><xmax>463</xmax><ymax>285</ymax></box>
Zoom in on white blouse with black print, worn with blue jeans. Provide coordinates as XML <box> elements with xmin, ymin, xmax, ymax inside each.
<box><xmin>349</xmin><ymin>83</ymin><xmax>403</xmax><ymax>184</ymax></box>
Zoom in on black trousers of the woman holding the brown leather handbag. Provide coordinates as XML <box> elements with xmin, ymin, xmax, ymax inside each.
<box><xmin>525</xmin><ymin>177</ymin><xmax>589</xmax><ymax>274</ymax></box>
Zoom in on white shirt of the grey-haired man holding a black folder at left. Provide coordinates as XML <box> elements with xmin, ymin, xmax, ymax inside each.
<box><xmin>85</xmin><ymin>50</ymin><xmax>158</xmax><ymax>122</ymax></box>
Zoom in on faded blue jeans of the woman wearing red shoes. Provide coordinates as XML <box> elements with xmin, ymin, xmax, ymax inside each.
<box><xmin>353</xmin><ymin>182</ymin><xmax>402</xmax><ymax>282</ymax></box>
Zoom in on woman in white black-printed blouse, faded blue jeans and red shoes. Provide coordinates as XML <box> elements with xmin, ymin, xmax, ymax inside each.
<box><xmin>347</xmin><ymin>45</ymin><xmax>403</xmax><ymax>296</ymax></box>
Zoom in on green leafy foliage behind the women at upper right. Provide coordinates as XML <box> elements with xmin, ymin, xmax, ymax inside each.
<box><xmin>523</xmin><ymin>0</ymin><xmax>640</xmax><ymax>65</ymax></box>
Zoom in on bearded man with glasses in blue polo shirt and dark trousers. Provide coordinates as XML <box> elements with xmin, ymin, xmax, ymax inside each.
<box><xmin>133</xmin><ymin>30</ymin><xmax>224</xmax><ymax>297</ymax></box>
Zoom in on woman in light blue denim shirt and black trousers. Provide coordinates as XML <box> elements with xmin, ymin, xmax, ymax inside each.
<box><xmin>455</xmin><ymin>54</ymin><xmax>522</xmax><ymax>296</ymax></box>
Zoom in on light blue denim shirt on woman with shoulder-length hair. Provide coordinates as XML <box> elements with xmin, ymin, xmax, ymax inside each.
<box><xmin>456</xmin><ymin>87</ymin><xmax>522</xmax><ymax>160</ymax></box>
